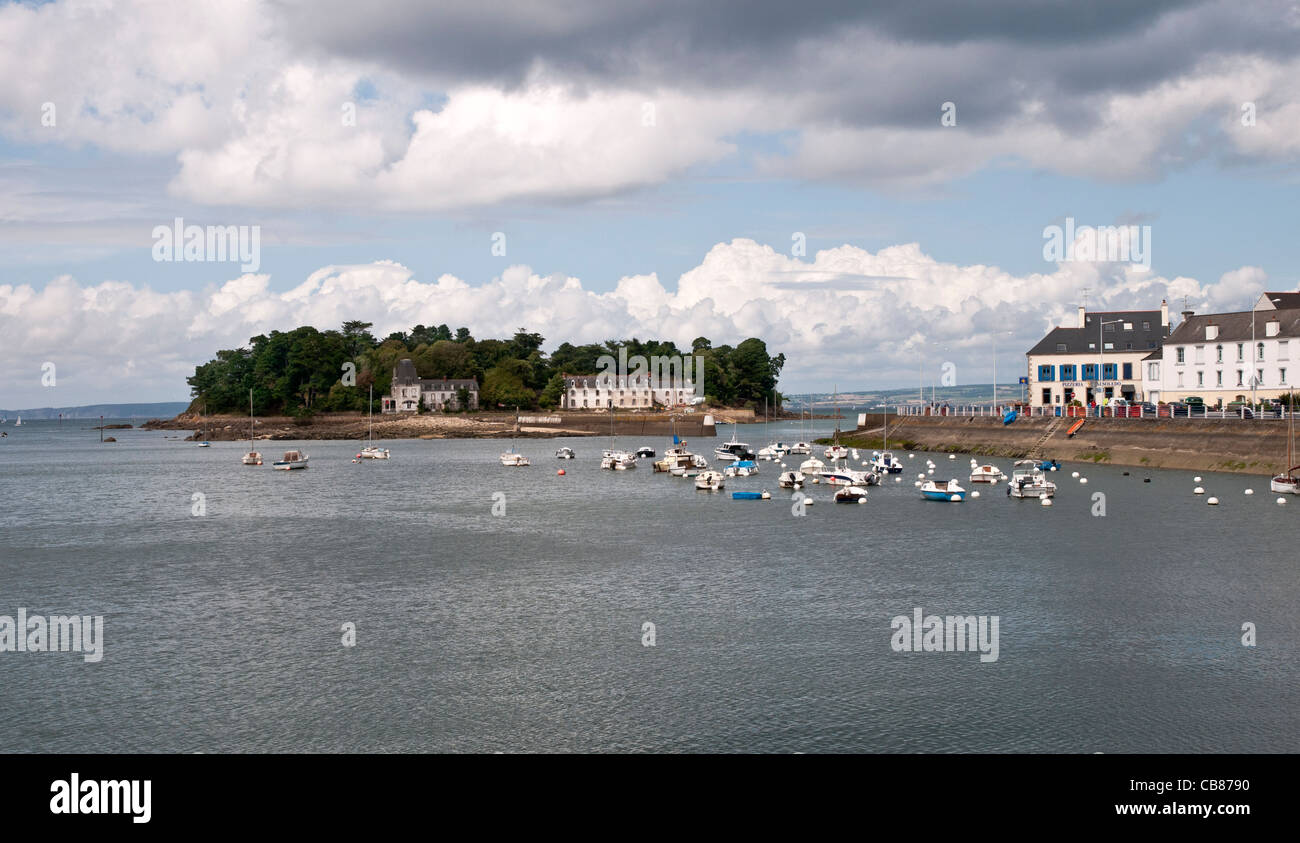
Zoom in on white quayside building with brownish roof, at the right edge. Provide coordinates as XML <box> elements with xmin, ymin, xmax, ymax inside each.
<box><xmin>1161</xmin><ymin>293</ymin><xmax>1300</xmax><ymax>405</ymax></box>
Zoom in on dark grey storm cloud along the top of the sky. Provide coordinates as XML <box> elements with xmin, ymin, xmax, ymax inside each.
<box><xmin>269</xmin><ymin>0</ymin><xmax>1300</xmax><ymax>130</ymax></box>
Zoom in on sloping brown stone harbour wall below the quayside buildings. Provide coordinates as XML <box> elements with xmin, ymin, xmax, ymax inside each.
<box><xmin>845</xmin><ymin>414</ymin><xmax>1288</xmax><ymax>475</ymax></box>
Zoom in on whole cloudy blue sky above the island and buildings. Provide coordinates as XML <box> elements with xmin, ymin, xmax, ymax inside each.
<box><xmin>0</xmin><ymin>0</ymin><xmax>1300</xmax><ymax>407</ymax></box>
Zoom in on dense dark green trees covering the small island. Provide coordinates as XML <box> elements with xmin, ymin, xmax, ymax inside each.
<box><xmin>187</xmin><ymin>321</ymin><xmax>785</xmax><ymax>415</ymax></box>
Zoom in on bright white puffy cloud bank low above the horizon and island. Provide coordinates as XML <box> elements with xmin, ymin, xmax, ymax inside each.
<box><xmin>0</xmin><ymin>239</ymin><xmax>1268</xmax><ymax>406</ymax></box>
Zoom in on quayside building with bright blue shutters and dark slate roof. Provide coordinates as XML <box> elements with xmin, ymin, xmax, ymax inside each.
<box><xmin>1027</xmin><ymin>302</ymin><xmax>1170</xmax><ymax>407</ymax></box>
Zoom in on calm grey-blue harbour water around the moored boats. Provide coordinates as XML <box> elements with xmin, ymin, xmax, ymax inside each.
<box><xmin>0</xmin><ymin>420</ymin><xmax>1300</xmax><ymax>753</ymax></box>
